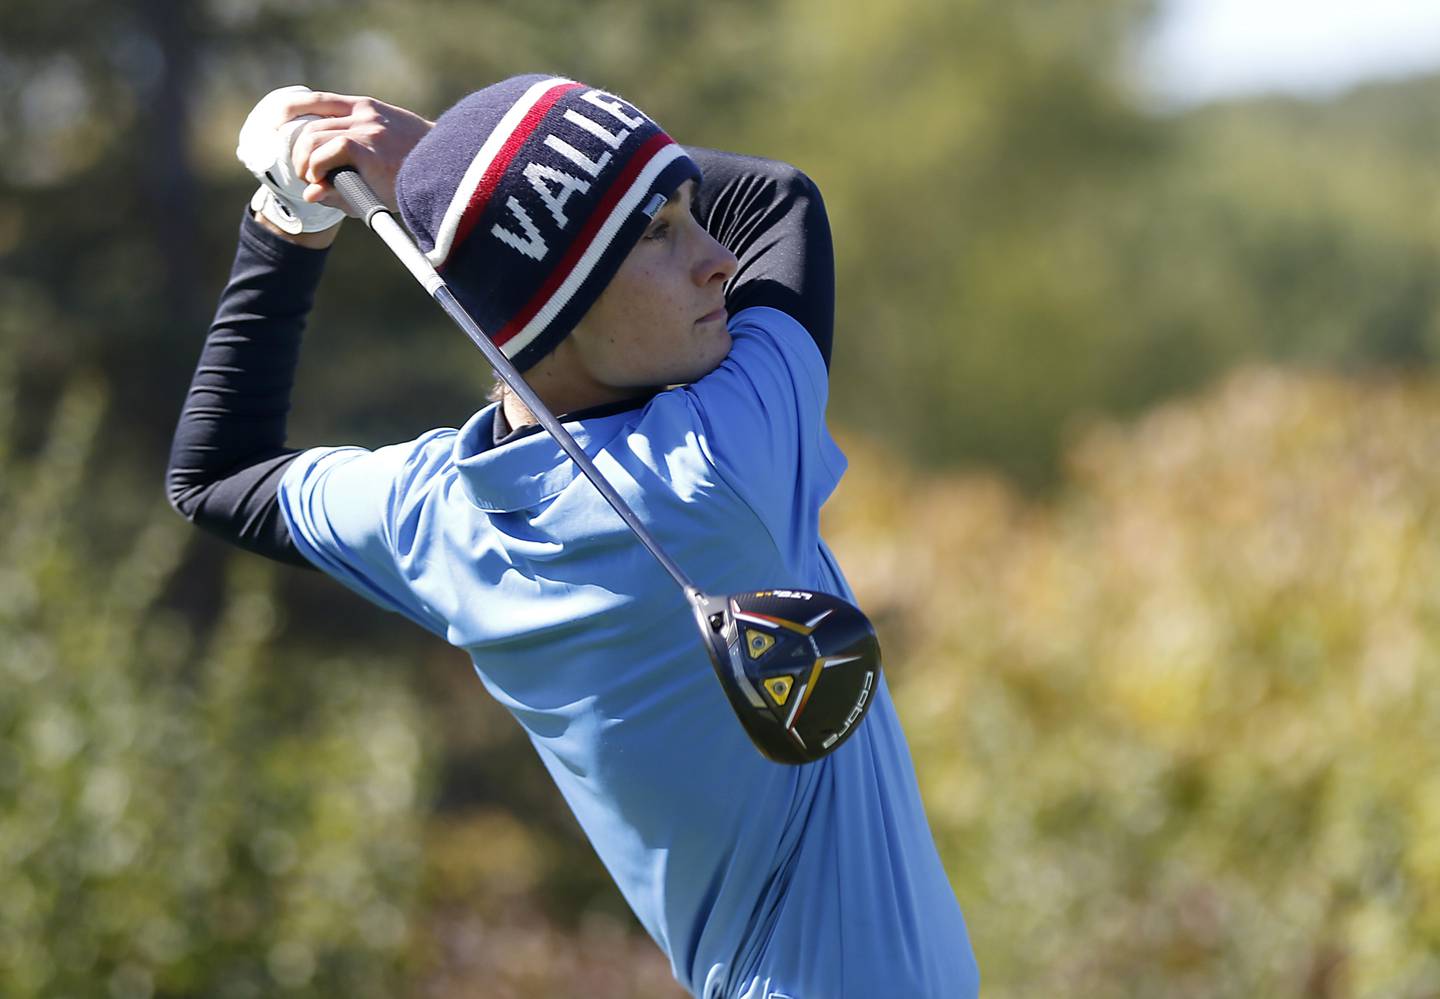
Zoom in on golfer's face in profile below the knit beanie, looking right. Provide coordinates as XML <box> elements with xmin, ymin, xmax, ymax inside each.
<box><xmin>572</xmin><ymin>181</ymin><xmax>736</xmax><ymax>389</ymax></box>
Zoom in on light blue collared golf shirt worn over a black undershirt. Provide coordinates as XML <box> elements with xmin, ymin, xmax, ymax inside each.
<box><xmin>279</xmin><ymin>308</ymin><xmax>978</xmax><ymax>999</ymax></box>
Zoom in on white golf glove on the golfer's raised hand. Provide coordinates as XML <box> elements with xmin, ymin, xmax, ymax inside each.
<box><xmin>235</xmin><ymin>85</ymin><xmax>346</xmax><ymax>235</ymax></box>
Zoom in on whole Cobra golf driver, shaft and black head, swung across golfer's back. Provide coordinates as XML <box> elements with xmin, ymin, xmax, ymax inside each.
<box><xmin>330</xmin><ymin>167</ymin><xmax>880</xmax><ymax>763</ymax></box>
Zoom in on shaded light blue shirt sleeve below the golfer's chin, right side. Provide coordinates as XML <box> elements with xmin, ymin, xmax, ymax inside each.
<box><xmin>690</xmin><ymin>308</ymin><xmax>845</xmax><ymax>566</ymax></box>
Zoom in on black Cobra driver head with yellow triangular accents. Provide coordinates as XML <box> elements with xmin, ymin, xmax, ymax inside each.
<box><xmin>693</xmin><ymin>590</ymin><xmax>880</xmax><ymax>763</ymax></box>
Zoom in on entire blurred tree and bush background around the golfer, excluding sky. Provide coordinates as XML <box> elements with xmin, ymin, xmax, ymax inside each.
<box><xmin>0</xmin><ymin>0</ymin><xmax>1440</xmax><ymax>999</ymax></box>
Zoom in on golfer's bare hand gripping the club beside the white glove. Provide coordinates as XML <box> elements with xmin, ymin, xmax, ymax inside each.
<box><xmin>285</xmin><ymin>91</ymin><xmax>435</xmax><ymax>212</ymax></box>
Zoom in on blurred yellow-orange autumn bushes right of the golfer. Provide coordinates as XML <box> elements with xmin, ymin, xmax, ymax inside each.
<box><xmin>827</xmin><ymin>370</ymin><xmax>1440</xmax><ymax>996</ymax></box>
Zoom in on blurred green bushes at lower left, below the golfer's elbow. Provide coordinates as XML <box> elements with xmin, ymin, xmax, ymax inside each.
<box><xmin>0</xmin><ymin>368</ymin><xmax>428</xmax><ymax>999</ymax></box>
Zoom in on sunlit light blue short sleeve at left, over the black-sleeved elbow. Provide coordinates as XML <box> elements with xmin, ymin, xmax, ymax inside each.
<box><xmin>278</xmin><ymin>430</ymin><xmax>455</xmax><ymax>638</ymax></box>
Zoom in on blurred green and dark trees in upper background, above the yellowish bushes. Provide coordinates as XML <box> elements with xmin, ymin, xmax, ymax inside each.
<box><xmin>0</xmin><ymin>0</ymin><xmax>1440</xmax><ymax>487</ymax></box>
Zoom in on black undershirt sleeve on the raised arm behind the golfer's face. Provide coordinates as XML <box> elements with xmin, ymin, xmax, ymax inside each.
<box><xmin>685</xmin><ymin>147</ymin><xmax>835</xmax><ymax>367</ymax></box>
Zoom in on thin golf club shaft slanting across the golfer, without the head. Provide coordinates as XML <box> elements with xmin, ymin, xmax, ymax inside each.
<box><xmin>330</xmin><ymin>167</ymin><xmax>700</xmax><ymax>605</ymax></box>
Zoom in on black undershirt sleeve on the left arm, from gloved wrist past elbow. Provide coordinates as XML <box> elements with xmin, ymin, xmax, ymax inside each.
<box><xmin>166</xmin><ymin>210</ymin><xmax>328</xmax><ymax>567</ymax></box>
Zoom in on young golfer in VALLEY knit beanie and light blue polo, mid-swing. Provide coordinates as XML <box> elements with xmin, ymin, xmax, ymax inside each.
<box><xmin>168</xmin><ymin>76</ymin><xmax>978</xmax><ymax>999</ymax></box>
